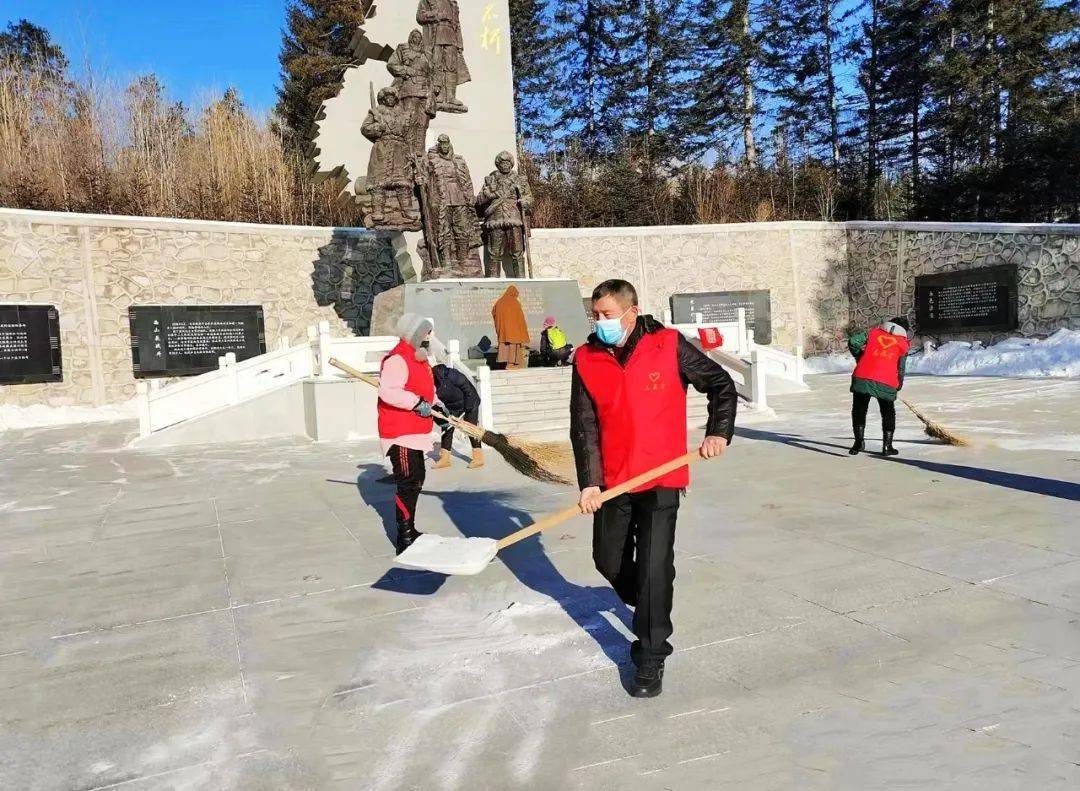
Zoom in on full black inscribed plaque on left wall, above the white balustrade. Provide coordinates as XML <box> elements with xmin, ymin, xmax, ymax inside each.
<box><xmin>127</xmin><ymin>305</ymin><xmax>267</xmax><ymax>379</ymax></box>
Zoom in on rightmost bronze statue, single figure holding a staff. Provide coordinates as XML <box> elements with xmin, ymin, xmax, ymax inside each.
<box><xmin>476</xmin><ymin>151</ymin><xmax>534</xmax><ymax>278</ymax></box>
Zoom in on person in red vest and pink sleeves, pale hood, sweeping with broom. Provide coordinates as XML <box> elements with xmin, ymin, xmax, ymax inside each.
<box><xmin>378</xmin><ymin>313</ymin><xmax>437</xmax><ymax>554</ymax></box>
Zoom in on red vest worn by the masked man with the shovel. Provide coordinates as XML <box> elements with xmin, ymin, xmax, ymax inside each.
<box><xmin>575</xmin><ymin>330</ymin><xmax>690</xmax><ymax>492</ymax></box>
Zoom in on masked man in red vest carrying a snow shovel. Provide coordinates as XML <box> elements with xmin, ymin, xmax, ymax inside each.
<box><xmin>570</xmin><ymin>280</ymin><xmax>738</xmax><ymax>697</ymax></box>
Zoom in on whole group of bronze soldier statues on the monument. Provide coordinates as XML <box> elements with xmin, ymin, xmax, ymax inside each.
<box><xmin>356</xmin><ymin>0</ymin><xmax>534</xmax><ymax>280</ymax></box>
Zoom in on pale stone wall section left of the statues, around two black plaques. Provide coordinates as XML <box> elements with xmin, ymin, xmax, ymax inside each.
<box><xmin>0</xmin><ymin>209</ymin><xmax>400</xmax><ymax>406</ymax></box>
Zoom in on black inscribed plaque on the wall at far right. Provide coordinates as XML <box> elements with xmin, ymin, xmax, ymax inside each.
<box><xmin>915</xmin><ymin>265</ymin><xmax>1020</xmax><ymax>332</ymax></box>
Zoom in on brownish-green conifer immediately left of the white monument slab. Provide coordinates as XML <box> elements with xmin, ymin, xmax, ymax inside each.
<box><xmin>276</xmin><ymin>0</ymin><xmax>373</xmax><ymax>146</ymax></box>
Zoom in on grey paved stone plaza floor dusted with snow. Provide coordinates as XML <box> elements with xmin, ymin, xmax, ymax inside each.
<box><xmin>0</xmin><ymin>376</ymin><xmax>1080</xmax><ymax>791</ymax></box>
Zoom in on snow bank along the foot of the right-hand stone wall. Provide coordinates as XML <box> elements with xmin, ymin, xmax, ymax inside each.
<box><xmin>806</xmin><ymin>330</ymin><xmax>1080</xmax><ymax>377</ymax></box>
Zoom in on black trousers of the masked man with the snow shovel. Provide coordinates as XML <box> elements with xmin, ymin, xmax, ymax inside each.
<box><xmin>593</xmin><ymin>488</ymin><xmax>681</xmax><ymax>666</ymax></box>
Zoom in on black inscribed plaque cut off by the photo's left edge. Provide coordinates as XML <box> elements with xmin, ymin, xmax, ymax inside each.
<box><xmin>0</xmin><ymin>305</ymin><xmax>64</xmax><ymax>385</ymax></box>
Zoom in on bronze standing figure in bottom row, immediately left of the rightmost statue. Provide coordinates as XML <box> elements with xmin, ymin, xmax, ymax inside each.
<box><xmin>424</xmin><ymin>135</ymin><xmax>484</xmax><ymax>280</ymax></box>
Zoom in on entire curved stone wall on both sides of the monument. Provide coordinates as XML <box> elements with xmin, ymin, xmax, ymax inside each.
<box><xmin>0</xmin><ymin>209</ymin><xmax>1080</xmax><ymax>406</ymax></box>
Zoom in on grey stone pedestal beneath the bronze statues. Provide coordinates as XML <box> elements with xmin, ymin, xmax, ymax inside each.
<box><xmin>372</xmin><ymin>279</ymin><xmax>590</xmax><ymax>357</ymax></box>
